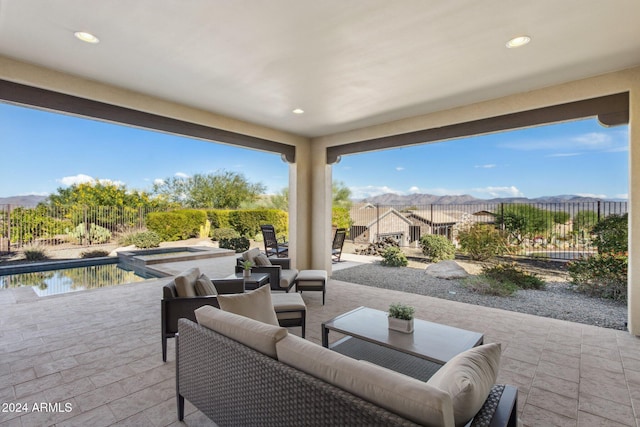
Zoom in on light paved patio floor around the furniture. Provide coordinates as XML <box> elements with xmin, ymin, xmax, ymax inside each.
<box><xmin>0</xmin><ymin>257</ymin><xmax>640</xmax><ymax>427</ymax></box>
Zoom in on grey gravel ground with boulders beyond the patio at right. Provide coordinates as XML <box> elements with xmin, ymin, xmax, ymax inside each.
<box><xmin>331</xmin><ymin>262</ymin><xmax>627</xmax><ymax>330</ymax></box>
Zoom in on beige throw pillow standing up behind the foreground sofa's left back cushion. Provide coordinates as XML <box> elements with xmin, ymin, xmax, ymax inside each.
<box><xmin>218</xmin><ymin>286</ymin><xmax>280</xmax><ymax>326</ymax></box>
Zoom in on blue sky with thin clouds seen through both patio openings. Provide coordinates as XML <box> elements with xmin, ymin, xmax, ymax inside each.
<box><xmin>0</xmin><ymin>103</ymin><xmax>628</xmax><ymax>199</ymax></box>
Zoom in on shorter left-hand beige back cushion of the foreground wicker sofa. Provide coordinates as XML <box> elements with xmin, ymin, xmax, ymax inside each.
<box><xmin>195</xmin><ymin>305</ymin><xmax>288</xmax><ymax>358</ymax></box>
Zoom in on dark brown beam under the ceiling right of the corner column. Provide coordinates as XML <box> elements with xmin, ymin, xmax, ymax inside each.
<box><xmin>327</xmin><ymin>92</ymin><xmax>629</xmax><ymax>164</ymax></box>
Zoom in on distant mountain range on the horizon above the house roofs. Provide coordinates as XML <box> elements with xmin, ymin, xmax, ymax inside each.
<box><xmin>357</xmin><ymin>193</ymin><xmax>626</xmax><ymax>206</ymax></box>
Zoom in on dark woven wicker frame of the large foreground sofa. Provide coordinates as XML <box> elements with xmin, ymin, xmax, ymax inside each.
<box><xmin>176</xmin><ymin>319</ymin><xmax>517</xmax><ymax>427</ymax></box>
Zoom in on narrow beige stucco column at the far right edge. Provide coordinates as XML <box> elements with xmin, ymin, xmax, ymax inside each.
<box><xmin>628</xmin><ymin>85</ymin><xmax>640</xmax><ymax>336</ymax></box>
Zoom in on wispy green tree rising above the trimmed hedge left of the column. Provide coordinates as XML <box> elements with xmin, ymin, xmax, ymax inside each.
<box><xmin>153</xmin><ymin>171</ymin><xmax>266</xmax><ymax>209</ymax></box>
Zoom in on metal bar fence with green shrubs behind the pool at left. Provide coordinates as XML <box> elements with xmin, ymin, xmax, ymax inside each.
<box><xmin>0</xmin><ymin>205</ymin><xmax>160</xmax><ymax>254</ymax></box>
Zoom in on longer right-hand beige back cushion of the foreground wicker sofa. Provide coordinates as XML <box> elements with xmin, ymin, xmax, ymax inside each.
<box><xmin>276</xmin><ymin>335</ymin><xmax>453</xmax><ymax>427</ymax></box>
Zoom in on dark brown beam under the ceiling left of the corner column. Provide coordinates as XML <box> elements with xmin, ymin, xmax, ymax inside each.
<box><xmin>0</xmin><ymin>80</ymin><xmax>296</xmax><ymax>162</ymax></box>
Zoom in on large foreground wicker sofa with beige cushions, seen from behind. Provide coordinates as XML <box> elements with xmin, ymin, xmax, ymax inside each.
<box><xmin>176</xmin><ymin>307</ymin><xmax>517</xmax><ymax>427</ymax></box>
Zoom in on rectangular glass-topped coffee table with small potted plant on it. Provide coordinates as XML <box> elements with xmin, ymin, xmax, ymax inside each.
<box><xmin>322</xmin><ymin>307</ymin><xmax>484</xmax><ymax>381</ymax></box>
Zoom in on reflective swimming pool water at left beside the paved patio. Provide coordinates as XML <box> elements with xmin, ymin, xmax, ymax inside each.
<box><xmin>0</xmin><ymin>263</ymin><xmax>157</xmax><ymax>297</ymax></box>
